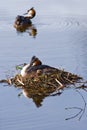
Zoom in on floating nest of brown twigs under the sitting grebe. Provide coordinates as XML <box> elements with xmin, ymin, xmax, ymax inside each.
<box><xmin>10</xmin><ymin>70</ymin><xmax>82</xmax><ymax>89</ymax></box>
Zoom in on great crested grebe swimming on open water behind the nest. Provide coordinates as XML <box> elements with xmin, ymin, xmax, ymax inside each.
<box><xmin>14</xmin><ymin>7</ymin><xmax>36</xmax><ymax>28</ymax></box>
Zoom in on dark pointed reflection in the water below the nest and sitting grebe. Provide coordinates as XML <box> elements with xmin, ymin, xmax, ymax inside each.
<box><xmin>18</xmin><ymin>86</ymin><xmax>62</xmax><ymax>107</ymax></box>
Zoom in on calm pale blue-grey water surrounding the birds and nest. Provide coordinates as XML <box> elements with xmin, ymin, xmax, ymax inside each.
<box><xmin>0</xmin><ymin>0</ymin><xmax>87</xmax><ymax>130</ymax></box>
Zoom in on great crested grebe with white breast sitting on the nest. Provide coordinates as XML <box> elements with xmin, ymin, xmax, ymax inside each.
<box><xmin>21</xmin><ymin>56</ymin><xmax>58</xmax><ymax>77</ymax></box>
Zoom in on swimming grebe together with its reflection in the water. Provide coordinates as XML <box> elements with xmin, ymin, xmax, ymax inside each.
<box><xmin>14</xmin><ymin>7</ymin><xmax>37</xmax><ymax>37</ymax></box>
